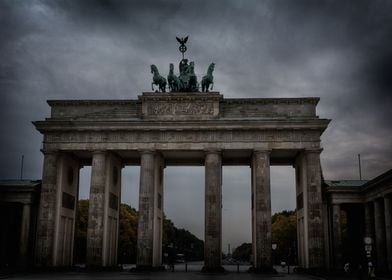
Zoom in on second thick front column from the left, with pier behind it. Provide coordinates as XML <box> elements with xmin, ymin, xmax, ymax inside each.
<box><xmin>87</xmin><ymin>151</ymin><xmax>122</xmax><ymax>267</ymax></box>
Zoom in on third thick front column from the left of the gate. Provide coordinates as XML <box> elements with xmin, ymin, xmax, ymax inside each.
<box><xmin>137</xmin><ymin>150</ymin><xmax>164</xmax><ymax>270</ymax></box>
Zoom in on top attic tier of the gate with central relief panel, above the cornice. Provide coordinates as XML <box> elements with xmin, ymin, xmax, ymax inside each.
<box><xmin>48</xmin><ymin>92</ymin><xmax>319</xmax><ymax>121</ymax></box>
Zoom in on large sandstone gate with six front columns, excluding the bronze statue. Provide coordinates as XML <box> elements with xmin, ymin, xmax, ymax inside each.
<box><xmin>34</xmin><ymin>92</ymin><xmax>329</xmax><ymax>271</ymax></box>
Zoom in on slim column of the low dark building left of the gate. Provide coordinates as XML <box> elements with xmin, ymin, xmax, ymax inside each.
<box><xmin>19</xmin><ymin>203</ymin><xmax>31</xmax><ymax>270</ymax></box>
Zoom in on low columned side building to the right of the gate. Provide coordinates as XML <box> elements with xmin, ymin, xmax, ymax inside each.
<box><xmin>324</xmin><ymin>169</ymin><xmax>392</xmax><ymax>271</ymax></box>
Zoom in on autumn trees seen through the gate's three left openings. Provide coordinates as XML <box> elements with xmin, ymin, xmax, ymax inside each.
<box><xmin>74</xmin><ymin>200</ymin><xmax>204</xmax><ymax>263</ymax></box>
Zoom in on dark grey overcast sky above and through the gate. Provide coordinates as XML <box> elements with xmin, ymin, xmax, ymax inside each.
<box><xmin>0</xmin><ymin>0</ymin><xmax>392</xmax><ymax>252</ymax></box>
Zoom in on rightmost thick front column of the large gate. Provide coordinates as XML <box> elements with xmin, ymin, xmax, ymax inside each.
<box><xmin>305</xmin><ymin>149</ymin><xmax>325</xmax><ymax>268</ymax></box>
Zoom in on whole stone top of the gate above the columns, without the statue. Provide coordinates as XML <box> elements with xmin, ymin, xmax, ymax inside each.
<box><xmin>34</xmin><ymin>92</ymin><xmax>329</xmax><ymax>156</ymax></box>
